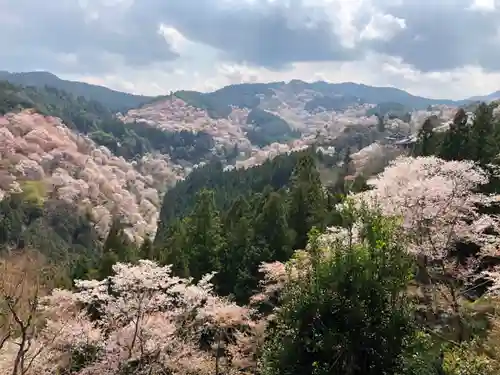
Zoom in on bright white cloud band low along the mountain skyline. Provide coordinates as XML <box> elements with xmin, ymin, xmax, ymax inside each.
<box><xmin>61</xmin><ymin>54</ymin><xmax>500</xmax><ymax>99</ymax></box>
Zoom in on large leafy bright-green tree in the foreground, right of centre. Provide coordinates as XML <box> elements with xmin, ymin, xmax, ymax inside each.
<box><xmin>262</xmin><ymin>204</ymin><xmax>414</xmax><ymax>375</ymax></box>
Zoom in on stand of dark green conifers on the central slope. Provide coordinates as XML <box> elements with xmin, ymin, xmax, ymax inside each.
<box><xmin>153</xmin><ymin>150</ymin><xmax>330</xmax><ymax>303</ymax></box>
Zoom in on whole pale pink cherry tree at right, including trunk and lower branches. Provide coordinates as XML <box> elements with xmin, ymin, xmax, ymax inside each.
<box><xmin>353</xmin><ymin>156</ymin><xmax>500</xmax><ymax>340</ymax></box>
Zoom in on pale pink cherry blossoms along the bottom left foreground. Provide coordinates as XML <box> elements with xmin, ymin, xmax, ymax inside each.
<box><xmin>0</xmin><ymin>260</ymin><xmax>257</xmax><ymax>375</ymax></box>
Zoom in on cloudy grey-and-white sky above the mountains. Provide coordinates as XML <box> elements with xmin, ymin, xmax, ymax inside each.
<box><xmin>0</xmin><ymin>0</ymin><xmax>500</xmax><ymax>98</ymax></box>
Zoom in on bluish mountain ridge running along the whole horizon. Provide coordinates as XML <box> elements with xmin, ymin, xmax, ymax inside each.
<box><xmin>0</xmin><ymin>71</ymin><xmax>500</xmax><ymax>117</ymax></box>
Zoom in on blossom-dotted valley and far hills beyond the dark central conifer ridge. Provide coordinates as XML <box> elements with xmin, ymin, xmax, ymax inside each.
<box><xmin>0</xmin><ymin>72</ymin><xmax>492</xmax><ymax>247</ymax></box>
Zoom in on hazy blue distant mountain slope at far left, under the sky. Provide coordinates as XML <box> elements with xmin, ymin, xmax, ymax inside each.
<box><xmin>0</xmin><ymin>71</ymin><xmax>153</xmax><ymax>112</ymax></box>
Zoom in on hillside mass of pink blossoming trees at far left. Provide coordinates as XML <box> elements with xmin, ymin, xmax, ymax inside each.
<box><xmin>0</xmin><ymin>110</ymin><xmax>183</xmax><ymax>242</ymax></box>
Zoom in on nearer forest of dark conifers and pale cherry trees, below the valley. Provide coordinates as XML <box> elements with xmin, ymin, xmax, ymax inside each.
<box><xmin>0</xmin><ymin>91</ymin><xmax>500</xmax><ymax>375</ymax></box>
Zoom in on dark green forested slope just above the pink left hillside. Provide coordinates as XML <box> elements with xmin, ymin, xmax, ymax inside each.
<box><xmin>0</xmin><ymin>81</ymin><xmax>214</xmax><ymax>162</ymax></box>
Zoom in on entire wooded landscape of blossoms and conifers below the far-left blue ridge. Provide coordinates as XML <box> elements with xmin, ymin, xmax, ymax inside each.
<box><xmin>4</xmin><ymin>73</ymin><xmax>500</xmax><ymax>375</ymax></box>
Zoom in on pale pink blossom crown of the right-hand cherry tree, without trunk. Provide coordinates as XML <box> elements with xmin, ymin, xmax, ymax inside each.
<box><xmin>353</xmin><ymin>157</ymin><xmax>497</xmax><ymax>259</ymax></box>
